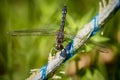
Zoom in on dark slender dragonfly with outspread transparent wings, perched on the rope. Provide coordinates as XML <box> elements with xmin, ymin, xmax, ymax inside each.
<box><xmin>8</xmin><ymin>4</ymin><xmax>108</xmax><ymax>52</ymax></box>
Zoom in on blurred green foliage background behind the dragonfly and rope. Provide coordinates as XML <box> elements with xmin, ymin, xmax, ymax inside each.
<box><xmin>0</xmin><ymin>0</ymin><xmax>120</xmax><ymax>80</ymax></box>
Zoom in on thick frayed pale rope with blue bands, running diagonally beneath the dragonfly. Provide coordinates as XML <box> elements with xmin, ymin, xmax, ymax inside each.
<box><xmin>27</xmin><ymin>0</ymin><xmax>120</xmax><ymax>80</ymax></box>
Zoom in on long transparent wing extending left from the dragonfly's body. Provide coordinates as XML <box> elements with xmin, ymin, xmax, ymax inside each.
<box><xmin>8</xmin><ymin>29</ymin><xmax>56</xmax><ymax>36</ymax></box>
